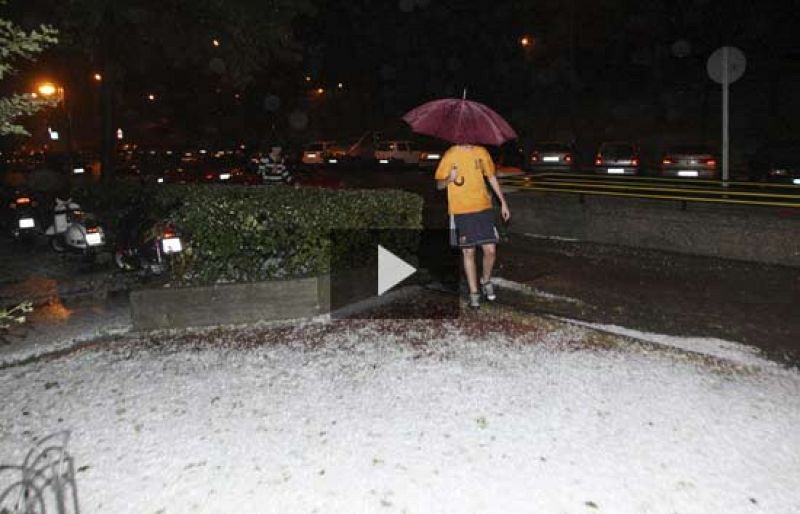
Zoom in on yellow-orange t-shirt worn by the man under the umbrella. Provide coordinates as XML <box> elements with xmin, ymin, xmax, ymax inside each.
<box><xmin>434</xmin><ymin>145</ymin><xmax>495</xmax><ymax>214</ymax></box>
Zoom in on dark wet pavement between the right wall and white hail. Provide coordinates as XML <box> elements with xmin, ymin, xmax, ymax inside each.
<box><xmin>496</xmin><ymin>234</ymin><xmax>800</xmax><ymax>364</ymax></box>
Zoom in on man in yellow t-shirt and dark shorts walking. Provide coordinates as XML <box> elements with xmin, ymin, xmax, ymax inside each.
<box><xmin>434</xmin><ymin>144</ymin><xmax>511</xmax><ymax>309</ymax></box>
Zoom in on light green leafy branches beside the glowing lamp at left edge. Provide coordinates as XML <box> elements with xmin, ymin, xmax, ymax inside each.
<box><xmin>0</xmin><ymin>0</ymin><xmax>58</xmax><ymax>136</ymax></box>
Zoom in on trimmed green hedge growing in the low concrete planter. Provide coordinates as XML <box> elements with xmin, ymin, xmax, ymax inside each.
<box><xmin>152</xmin><ymin>185</ymin><xmax>422</xmax><ymax>284</ymax></box>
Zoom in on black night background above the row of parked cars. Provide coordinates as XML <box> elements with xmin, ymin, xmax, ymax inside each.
<box><xmin>5</xmin><ymin>0</ymin><xmax>800</xmax><ymax>163</ymax></box>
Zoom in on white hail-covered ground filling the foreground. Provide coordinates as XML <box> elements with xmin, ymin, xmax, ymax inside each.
<box><xmin>0</xmin><ymin>309</ymin><xmax>800</xmax><ymax>514</ymax></box>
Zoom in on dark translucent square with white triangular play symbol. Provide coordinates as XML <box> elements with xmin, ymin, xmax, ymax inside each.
<box><xmin>322</xmin><ymin>229</ymin><xmax>460</xmax><ymax>319</ymax></box>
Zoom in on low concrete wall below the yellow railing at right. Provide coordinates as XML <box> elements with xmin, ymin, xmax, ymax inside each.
<box><xmin>509</xmin><ymin>192</ymin><xmax>800</xmax><ymax>267</ymax></box>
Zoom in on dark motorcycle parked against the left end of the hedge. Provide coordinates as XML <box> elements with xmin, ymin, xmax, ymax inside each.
<box><xmin>114</xmin><ymin>219</ymin><xmax>183</xmax><ymax>275</ymax></box>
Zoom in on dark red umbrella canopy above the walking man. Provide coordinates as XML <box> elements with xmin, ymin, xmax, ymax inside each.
<box><xmin>403</xmin><ymin>98</ymin><xmax>517</xmax><ymax>145</ymax></box>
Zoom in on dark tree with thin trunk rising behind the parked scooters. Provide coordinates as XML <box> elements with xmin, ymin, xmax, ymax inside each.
<box><xmin>18</xmin><ymin>0</ymin><xmax>313</xmax><ymax>178</ymax></box>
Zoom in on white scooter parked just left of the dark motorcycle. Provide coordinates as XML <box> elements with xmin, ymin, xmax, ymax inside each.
<box><xmin>45</xmin><ymin>198</ymin><xmax>105</xmax><ymax>258</ymax></box>
